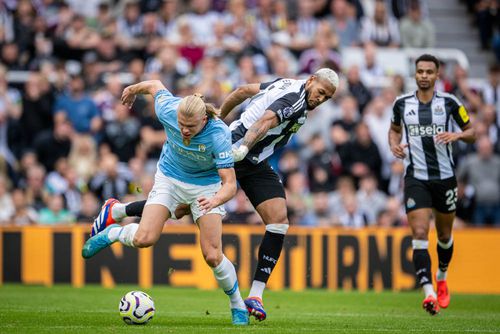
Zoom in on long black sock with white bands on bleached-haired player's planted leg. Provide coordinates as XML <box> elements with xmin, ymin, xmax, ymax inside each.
<box><xmin>249</xmin><ymin>224</ymin><xmax>288</xmax><ymax>299</ymax></box>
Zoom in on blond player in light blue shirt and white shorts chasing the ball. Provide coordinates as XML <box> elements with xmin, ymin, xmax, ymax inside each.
<box><xmin>82</xmin><ymin>80</ymin><xmax>248</xmax><ymax>325</ymax></box>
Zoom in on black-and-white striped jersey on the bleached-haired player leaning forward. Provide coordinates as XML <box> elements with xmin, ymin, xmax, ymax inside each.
<box><xmin>229</xmin><ymin>79</ymin><xmax>308</xmax><ymax>164</ymax></box>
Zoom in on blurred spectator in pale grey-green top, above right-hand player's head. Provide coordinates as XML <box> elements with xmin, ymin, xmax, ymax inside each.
<box><xmin>399</xmin><ymin>0</ymin><xmax>436</xmax><ymax>48</ymax></box>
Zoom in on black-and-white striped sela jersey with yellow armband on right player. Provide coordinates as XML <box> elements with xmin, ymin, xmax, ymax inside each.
<box><xmin>392</xmin><ymin>91</ymin><xmax>469</xmax><ymax>180</ymax></box>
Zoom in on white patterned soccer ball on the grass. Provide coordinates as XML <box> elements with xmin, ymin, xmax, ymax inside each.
<box><xmin>118</xmin><ymin>291</ymin><xmax>155</xmax><ymax>325</ymax></box>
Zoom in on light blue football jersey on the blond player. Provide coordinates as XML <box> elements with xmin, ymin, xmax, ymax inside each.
<box><xmin>155</xmin><ymin>90</ymin><xmax>234</xmax><ymax>185</ymax></box>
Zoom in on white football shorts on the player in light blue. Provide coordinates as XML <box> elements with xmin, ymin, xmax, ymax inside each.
<box><xmin>146</xmin><ymin>169</ymin><xmax>226</xmax><ymax>223</ymax></box>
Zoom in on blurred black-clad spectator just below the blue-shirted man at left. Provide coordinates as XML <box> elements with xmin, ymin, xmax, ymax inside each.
<box><xmin>35</xmin><ymin>120</ymin><xmax>73</xmax><ymax>172</ymax></box>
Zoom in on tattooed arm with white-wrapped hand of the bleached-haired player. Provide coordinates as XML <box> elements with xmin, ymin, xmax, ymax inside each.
<box><xmin>233</xmin><ymin>110</ymin><xmax>279</xmax><ymax>162</ymax></box>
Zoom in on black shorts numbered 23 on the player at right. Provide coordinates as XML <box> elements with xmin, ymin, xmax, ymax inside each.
<box><xmin>404</xmin><ymin>176</ymin><xmax>457</xmax><ymax>213</ymax></box>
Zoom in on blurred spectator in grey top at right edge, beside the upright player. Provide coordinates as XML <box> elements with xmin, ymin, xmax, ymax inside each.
<box><xmin>458</xmin><ymin>136</ymin><xmax>500</xmax><ymax>226</ymax></box>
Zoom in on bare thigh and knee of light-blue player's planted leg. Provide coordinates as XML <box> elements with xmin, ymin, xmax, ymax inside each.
<box><xmin>197</xmin><ymin>213</ymin><xmax>222</xmax><ymax>267</ymax></box>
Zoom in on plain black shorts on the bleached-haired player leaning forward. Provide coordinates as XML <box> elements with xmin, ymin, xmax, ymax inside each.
<box><xmin>234</xmin><ymin>159</ymin><xmax>286</xmax><ymax>208</ymax></box>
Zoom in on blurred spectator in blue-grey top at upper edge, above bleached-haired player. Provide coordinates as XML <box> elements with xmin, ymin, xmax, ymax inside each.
<box><xmin>328</xmin><ymin>0</ymin><xmax>359</xmax><ymax>48</ymax></box>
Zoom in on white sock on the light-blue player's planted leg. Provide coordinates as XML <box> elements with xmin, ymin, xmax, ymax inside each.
<box><xmin>212</xmin><ymin>255</ymin><xmax>246</xmax><ymax>309</ymax></box>
